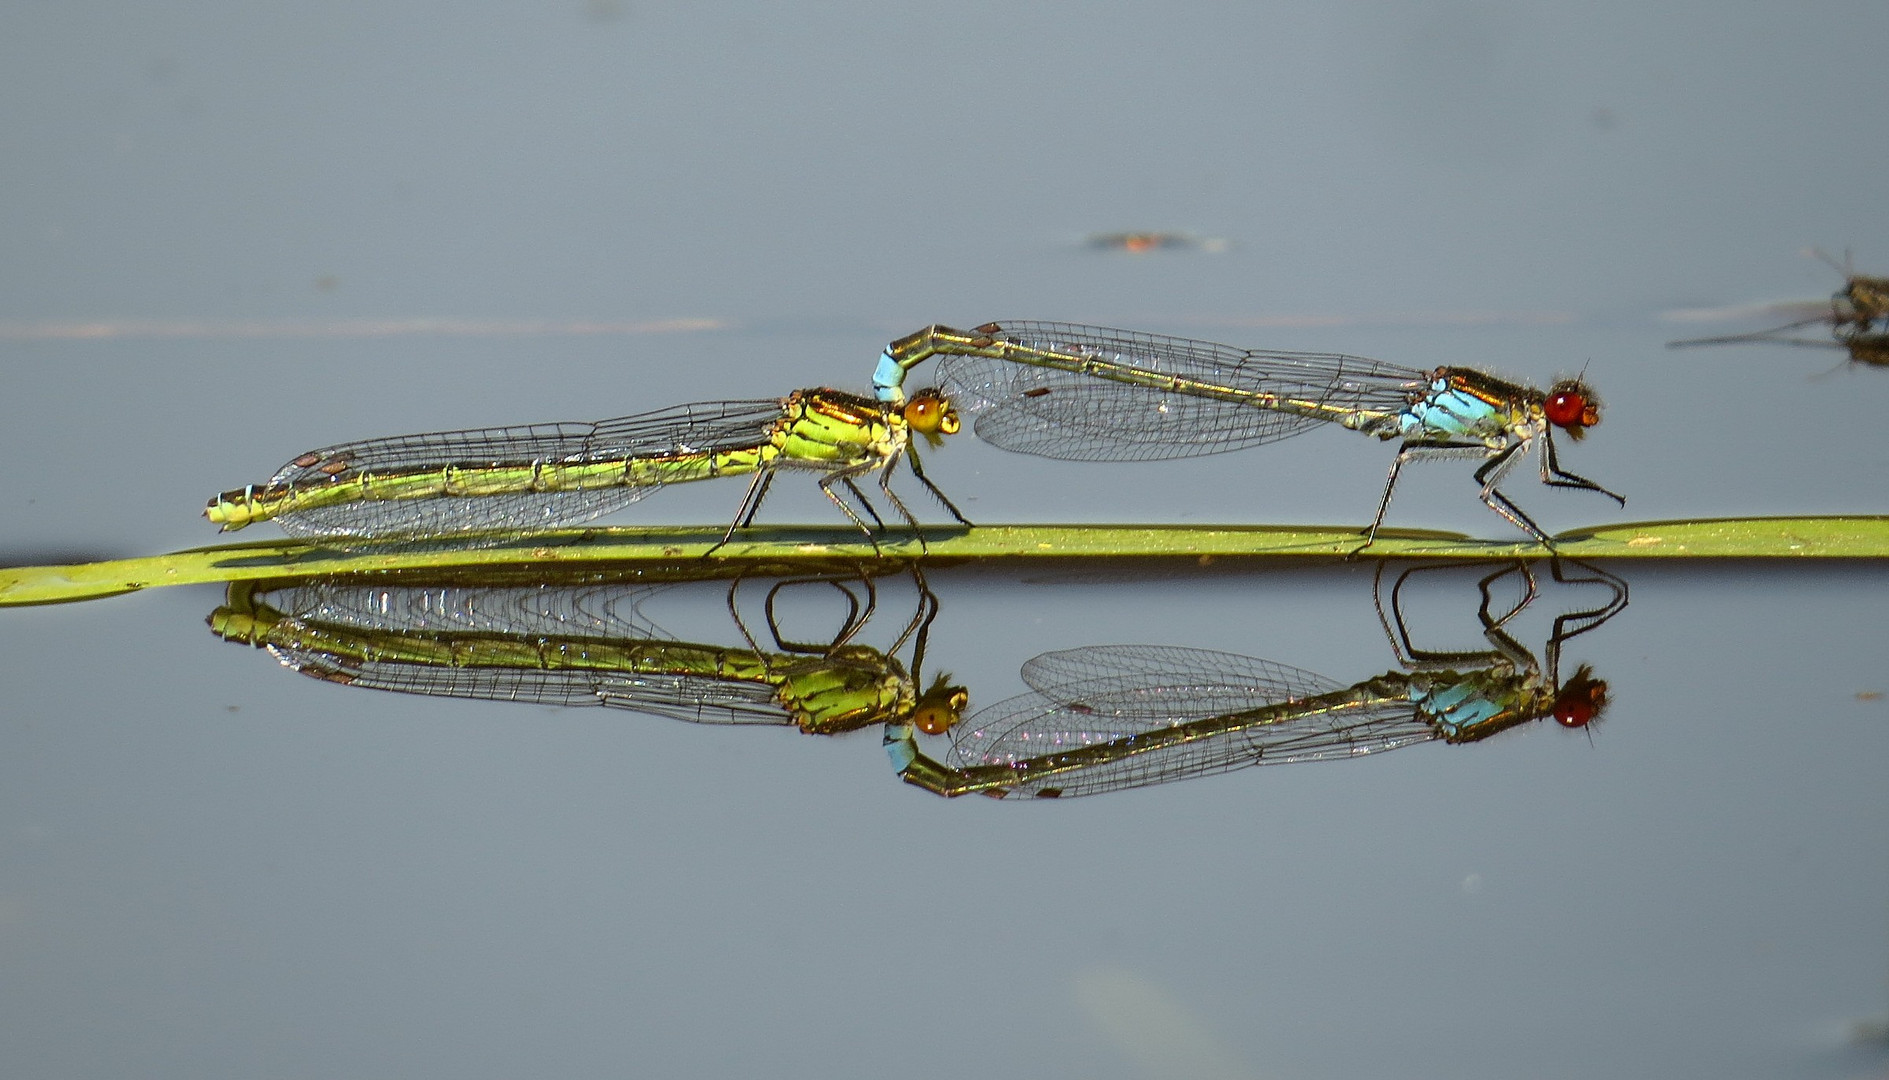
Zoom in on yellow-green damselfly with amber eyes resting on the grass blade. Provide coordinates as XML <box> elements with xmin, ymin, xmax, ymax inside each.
<box><xmin>204</xmin><ymin>389</ymin><xmax>963</xmax><ymax>546</ymax></box>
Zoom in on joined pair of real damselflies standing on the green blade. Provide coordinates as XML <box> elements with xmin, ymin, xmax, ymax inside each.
<box><xmin>204</xmin><ymin>321</ymin><xmax>1625</xmax><ymax>549</ymax></box>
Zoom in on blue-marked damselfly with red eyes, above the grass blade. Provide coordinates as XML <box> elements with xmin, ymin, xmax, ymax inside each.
<box><xmin>873</xmin><ymin>323</ymin><xmax>1626</xmax><ymax>548</ymax></box>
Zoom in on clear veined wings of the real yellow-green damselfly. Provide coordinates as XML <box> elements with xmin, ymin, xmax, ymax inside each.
<box><xmin>270</xmin><ymin>398</ymin><xmax>782</xmax><ymax>536</ymax></box>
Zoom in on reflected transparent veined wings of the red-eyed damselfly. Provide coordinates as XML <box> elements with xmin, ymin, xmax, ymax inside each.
<box><xmin>952</xmin><ymin>646</ymin><xmax>1436</xmax><ymax>797</ymax></box>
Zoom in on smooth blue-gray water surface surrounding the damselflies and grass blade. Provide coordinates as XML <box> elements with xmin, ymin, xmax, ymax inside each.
<box><xmin>0</xmin><ymin>0</ymin><xmax>1889</xmax><ymax>1078</ymax></box>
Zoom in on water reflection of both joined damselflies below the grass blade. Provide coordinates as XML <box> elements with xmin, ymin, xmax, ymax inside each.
<box><xmin>210</xmin><ymin>563</ymin><xmax>1626</xmax><ymax>799</ymax></box>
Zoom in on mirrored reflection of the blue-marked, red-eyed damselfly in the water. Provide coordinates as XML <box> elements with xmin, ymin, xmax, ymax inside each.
<box><xmin>886</xmin><ymin>561</ymin><xmax>1626</xmax><ymax>799</ymax></box>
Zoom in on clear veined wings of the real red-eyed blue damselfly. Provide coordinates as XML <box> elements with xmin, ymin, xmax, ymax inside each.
<box><xmin>939</xmin><ymin>321</ymin><xmax>1428</xmax><ymax>461</ymax></box>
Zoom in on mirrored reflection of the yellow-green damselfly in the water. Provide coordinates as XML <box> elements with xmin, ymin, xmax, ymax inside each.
<box><xmin>210</xmin><ymin>563</ymin><xmax>965</xmax><ymax>734</ymax></box>
